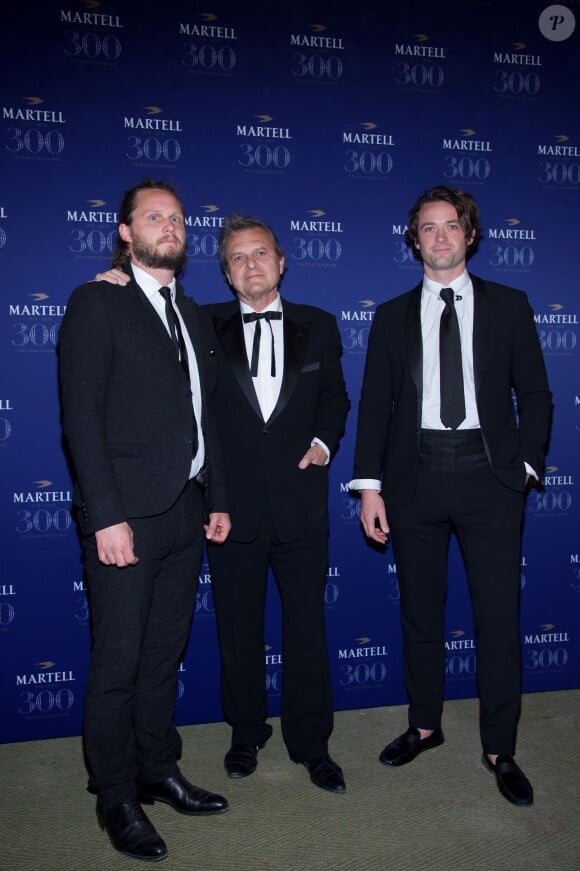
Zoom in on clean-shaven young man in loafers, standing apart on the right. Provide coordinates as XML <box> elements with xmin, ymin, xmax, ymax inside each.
<box><xmin>350</xmin><ymin>187</ymin><xmax>551</xmax><ymax>805</ymax></box>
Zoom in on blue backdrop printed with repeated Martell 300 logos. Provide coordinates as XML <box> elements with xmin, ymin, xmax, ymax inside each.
<box><xmin>0</xmin><ymin>0</ymin><xmax>580</xmax><ymax>742</ymax></box>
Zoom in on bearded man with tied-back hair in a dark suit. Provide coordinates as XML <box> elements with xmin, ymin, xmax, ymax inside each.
<box><xmin>59</xmin><ymin>180</ymin><xmax>230</xmax><ymax>861</ymax></box>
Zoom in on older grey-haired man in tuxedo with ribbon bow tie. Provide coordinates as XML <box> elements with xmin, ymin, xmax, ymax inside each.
<box><xmin>206</xmin><ymin>214</ymin><xmax>349</xmax><ymax>793</ymax></box>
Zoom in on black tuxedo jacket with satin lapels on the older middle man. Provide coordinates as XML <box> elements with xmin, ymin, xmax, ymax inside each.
<box><xmin>206</xmin><ymin>300</ymin><xmax>349</xmax><ymax>541</ymax></box>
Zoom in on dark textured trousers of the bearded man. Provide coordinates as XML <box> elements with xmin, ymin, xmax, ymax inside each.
<box><xmin>83</xmin><ymin>481</ymin><xmax>204</xmax><ymax>806</ymax></box>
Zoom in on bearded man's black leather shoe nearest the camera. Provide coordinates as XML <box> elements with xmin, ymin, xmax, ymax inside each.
<box><xmin>97</xmin><ymin>798</ymin><xmax>168</xmax><ymax>862</ymax></box>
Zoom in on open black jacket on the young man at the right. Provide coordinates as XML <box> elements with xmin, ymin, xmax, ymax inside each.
<box><xmin>353</xmin><ymin>275</ymin><xmax>551</xmax><ymax>504</ymax></box>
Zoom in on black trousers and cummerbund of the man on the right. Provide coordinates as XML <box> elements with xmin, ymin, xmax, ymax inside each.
<box><xmin>387</xmin><ymin>431</ymin><xmax>523</xmax><ymax>754</ymax></box>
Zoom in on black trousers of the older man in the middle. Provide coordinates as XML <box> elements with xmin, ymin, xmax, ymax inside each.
<box><xmin>208</xmin><ymin>505</ymin><xmax>333</xmax><ymax>761</ymax></box>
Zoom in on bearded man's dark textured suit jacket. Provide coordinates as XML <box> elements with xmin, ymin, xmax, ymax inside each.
<box><xmin>59</xmin><ymin>268</ymin><xmax>228</xmax><ymax>532</ymax></box>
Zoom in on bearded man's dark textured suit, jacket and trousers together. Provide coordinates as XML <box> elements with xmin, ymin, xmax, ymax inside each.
<box><xmin>59</xmin><ymin>267</ymin><xmax>227</xmax><ymax>807</ymax></box>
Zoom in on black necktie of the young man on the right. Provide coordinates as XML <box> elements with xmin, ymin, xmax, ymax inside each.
<box><xmin>439</xmin><ymin>287</ymin><xmax>465</xmax><ymax>429</ymax></box>
